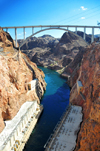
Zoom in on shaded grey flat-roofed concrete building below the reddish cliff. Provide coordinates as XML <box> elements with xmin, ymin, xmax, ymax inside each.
<box><xmin>44</xmin><ymin>105</ymin><xmax>82</xmax><ymax>151</ymax></box>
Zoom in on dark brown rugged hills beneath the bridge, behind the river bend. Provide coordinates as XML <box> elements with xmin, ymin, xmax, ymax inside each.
<box><xmin>22</xmin><ymin>32</ymin><xmax>87</xmax><ymax>77</ymax></box>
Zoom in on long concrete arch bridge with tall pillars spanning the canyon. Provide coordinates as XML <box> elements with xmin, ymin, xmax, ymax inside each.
<box><xmin>2</xmin><ymin>25</ymin><xmax>100</xmax><ymax>48</ymax></box>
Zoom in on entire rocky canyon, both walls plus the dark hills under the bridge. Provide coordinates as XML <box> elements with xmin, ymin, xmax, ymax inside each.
<box><xmin>0</xmin><ymin>28</ymin><xmax>100</xmax><ymax>151</ymax></box>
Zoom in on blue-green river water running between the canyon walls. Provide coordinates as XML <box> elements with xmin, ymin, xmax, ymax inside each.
<box><xmin>24</xmin><ymin>67</ymin><xmax>70</xmax><ymax>151</ymax></box>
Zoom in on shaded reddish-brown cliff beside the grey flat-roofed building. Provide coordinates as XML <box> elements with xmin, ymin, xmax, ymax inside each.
<box><xmin>69</xmin><ymin>43</ymin><xmax>100</xmax><ymax>151</ymax></box>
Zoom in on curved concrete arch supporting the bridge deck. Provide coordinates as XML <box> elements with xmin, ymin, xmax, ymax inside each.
<box><xmin>19</xmin><ymin>27</ymin><xmax>84</xmax><ymax>49</ymax></box>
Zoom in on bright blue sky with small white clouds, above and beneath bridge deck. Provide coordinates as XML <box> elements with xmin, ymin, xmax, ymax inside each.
<box><xmin>0</xmin><ymin>0</ymin><xmax>100</xmax><ymax>39</ymax></box>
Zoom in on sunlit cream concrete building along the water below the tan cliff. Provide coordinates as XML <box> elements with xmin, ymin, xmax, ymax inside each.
<box><xmin>0</xmin><ymin>101</ymin><xmax>43</xmax><ymax>151</ymax></box>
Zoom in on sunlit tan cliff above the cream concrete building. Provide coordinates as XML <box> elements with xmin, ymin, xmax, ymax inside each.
<box><xmin>0</xmin><ymin>29</ymin><xmax>46</xmax><ymax>132</ymax></box>
